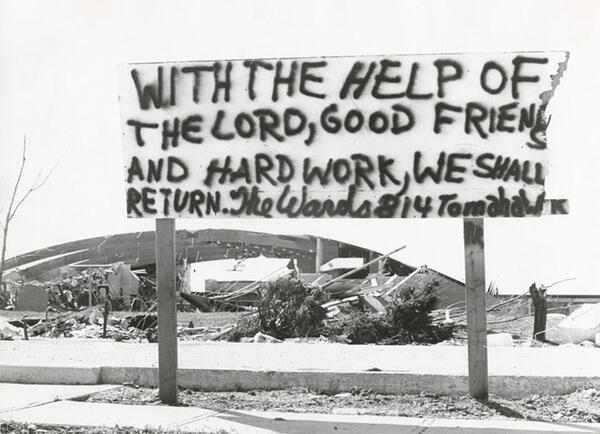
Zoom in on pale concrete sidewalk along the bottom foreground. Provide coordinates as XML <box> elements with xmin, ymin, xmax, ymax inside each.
<box><xmin>0</xmin><ymin>384</ymin><xmax>600</xmax><ymax>434</ymax></box>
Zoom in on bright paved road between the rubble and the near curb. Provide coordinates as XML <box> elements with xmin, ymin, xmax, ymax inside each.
<box><xmin>0</xmin><ymin>339</ymin><xmax>600</xmax><ymax>377</ymax></box>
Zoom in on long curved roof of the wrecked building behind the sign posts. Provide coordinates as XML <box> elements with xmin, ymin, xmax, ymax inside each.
<box><xmin>5</xmin><ymin>229</ymin><xmax>415</xmax><ymax>279</ymax></box>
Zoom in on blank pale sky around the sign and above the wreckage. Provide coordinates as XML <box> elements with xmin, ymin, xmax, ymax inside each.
<box><xmin>0</xmin><ymin>0</ymin><xmax>600</xmax><ymax>293</ymax></box>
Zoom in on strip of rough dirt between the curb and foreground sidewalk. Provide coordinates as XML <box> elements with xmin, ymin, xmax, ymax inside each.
<box><xmin>89</xmin><ymin>386</ymin><xmax>600</xmax><ymax>423</ymax></box>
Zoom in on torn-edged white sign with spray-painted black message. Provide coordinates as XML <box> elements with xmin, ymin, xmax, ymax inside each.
<box><xmin>119</xmin><ymin>52</ymin><xmax>568</xmax><ymax>218</ymax></box>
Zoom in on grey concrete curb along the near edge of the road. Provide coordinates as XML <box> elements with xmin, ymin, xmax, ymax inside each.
<box><xmin>0</xmin><ymin>365</ymin><xmax>600</xmax><ymax>399</ymax></box>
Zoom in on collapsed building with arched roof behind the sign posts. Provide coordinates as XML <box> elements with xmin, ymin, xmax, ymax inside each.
<box><xmin>0</xmin><ymin>229</ymin><xmax>478</xmax><ymax>310</ymax></box>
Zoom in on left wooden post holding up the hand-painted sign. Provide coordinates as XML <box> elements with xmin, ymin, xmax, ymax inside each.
<box><xmin>156</xmin><ymin>218</ymin><xmax>177</xmax><ymax>405</ymax></box>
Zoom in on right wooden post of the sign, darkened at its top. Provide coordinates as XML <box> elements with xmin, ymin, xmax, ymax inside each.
<box><xmin>463</xmin><ymin>218</ymin><xmax>488</xmax><ymax>399</ymax></box>
